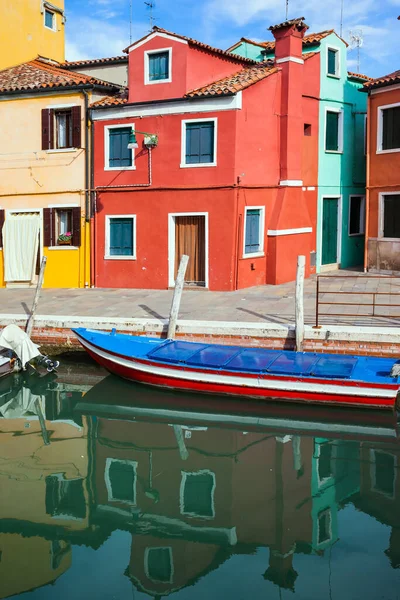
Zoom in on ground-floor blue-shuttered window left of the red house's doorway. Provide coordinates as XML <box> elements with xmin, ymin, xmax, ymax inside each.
<box><xmin>105</xmin><ymin>215</ymin><xmax>136</xmax><ymax>259</ymax></box>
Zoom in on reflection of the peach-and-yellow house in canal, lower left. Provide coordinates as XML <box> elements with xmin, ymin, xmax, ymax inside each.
<box><xmin>0</xmin><ymin>378</ymin><xmax>91</xmax><ymax>598</ymax></box>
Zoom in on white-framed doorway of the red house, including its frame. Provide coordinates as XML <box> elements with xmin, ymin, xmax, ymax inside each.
<box><xmin>169</xmin><ymin>214</ymin><xmax>208</xmax><ymax>287</ymax></box>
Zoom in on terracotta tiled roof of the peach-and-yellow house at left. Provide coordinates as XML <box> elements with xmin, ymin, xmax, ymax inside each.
<box><xmin>0</xmin><ymin>58</ymin><xmax>120</xmax><ymax>94</ymax></box>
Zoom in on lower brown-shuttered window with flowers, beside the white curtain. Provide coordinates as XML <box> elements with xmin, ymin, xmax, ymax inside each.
<box><xmin>43</xmin><ymin>206</ymin><xmax>82</xmax><ymax>247</ymax></box>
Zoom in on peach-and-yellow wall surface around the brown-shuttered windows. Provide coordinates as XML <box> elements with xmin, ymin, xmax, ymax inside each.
<box><xmin>0</xmin><ymin>93</ymin><xmax>90</xmax><ymax>288</ymax></box>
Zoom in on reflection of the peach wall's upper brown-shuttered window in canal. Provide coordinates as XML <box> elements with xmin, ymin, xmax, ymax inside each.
<box><xmin>46</xmin><ymin>473</ymin><xmax>86</xmax><ymax>519</ymax></box>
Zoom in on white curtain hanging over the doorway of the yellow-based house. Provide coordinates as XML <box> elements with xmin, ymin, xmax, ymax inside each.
<box><xmin>3</xmin><ymin>213</ymin><xmax>40</xmax><ymax>281</ymax></box>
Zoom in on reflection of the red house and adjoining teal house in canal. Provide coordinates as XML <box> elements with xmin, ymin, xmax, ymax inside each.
<box><xmin>92</xmin><ymin>418</ymin><xmax>359</xmax><ymax>596</ymax></box>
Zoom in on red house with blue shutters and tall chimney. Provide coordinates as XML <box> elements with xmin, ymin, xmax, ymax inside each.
<box><xmin>92</xmin><ymin>19</ymin><xmax>320</xmax><ymax>291</ymax></box>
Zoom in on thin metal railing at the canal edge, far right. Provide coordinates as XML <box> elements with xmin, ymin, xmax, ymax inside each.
<box><xmin>315</xmin><ymin>275</ymin><xmax>400</xmax><ymax>328</ymax></box>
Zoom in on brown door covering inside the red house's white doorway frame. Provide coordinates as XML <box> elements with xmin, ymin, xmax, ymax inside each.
<box><xmin>175</xmin><ymin>216</ymin><xmax>206</xmax><ymax>286</ymax></box>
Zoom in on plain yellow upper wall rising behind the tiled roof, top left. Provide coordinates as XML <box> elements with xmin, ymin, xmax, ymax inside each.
<box><xmin>0</xmin><ymin>0</ymin><xmax>65</xmax><ymax>69</ymax></box>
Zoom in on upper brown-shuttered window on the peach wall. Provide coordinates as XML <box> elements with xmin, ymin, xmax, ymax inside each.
<box><xmin>42</xmin><ymin>106</ymin><xmax>82</xmax><ymax>150</ymax></box>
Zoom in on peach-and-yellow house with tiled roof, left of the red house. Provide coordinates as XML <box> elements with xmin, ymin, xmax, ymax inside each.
<box><xmin>0</xmin><ymin>58</ymin><xmax>120</xmax><ymax>288</ymax></box>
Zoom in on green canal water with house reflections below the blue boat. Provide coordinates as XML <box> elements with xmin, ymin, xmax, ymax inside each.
<box><xmin>0</xmin><ymin>364</ymin><xmax>400</xmax><ymax>600</ymax></box>
